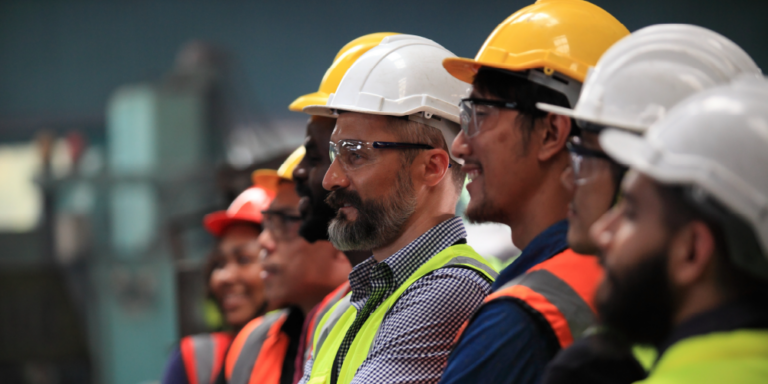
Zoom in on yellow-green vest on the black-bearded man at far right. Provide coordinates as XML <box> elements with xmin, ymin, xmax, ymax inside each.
<box><xmin>635</xmin><ymin>329</ymin><xmax>768</xmax><ymax>384</ymax></box>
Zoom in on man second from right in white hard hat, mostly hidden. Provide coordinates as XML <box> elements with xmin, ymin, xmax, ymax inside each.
<box><xmin>538</xmin><ymin>24</ymin><xmax>760</xmax><ymax>384</ymax></box>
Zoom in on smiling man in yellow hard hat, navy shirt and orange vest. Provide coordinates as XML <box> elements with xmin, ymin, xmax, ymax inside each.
<box><xmin>441</xmin><ymin>0</ymin><xmax>629</xmax><ymax>383</ymax></box>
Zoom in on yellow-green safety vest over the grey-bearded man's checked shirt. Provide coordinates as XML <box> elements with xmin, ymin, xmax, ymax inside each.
<box><xmin>309</xmin><ymin>244</ymin><xmax>497</xmax><ymax>384</ymax></box>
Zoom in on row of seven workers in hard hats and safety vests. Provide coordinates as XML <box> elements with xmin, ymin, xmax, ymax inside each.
<box><xmin>160</xmin><ymin>0</ymin><xmax>768</xmax><ymax>384</ymax></box>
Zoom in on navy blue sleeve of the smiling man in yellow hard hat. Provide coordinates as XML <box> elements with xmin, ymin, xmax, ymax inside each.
<box><xmin>440</xmin><ymin>300</ymin><xmax>556</xmax><ymax>384</ymax></box>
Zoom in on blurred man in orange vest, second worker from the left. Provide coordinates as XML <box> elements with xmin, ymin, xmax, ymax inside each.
<box><xmin>225</xmin><ymin>158</ymin><xmax>351</xmax><ymax>384</ymax></box>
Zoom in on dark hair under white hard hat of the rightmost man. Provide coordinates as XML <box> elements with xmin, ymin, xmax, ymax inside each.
<box><xmin>656</xmin><ymin>183</ymin><xmax>768</xmax><ymax>295</ymax></box>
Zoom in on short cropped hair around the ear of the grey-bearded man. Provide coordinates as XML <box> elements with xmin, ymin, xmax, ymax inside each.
<box><xmin>390</xmin><ymin>116</ymin><xmax>467</xmax><ymax>191</ymax></box>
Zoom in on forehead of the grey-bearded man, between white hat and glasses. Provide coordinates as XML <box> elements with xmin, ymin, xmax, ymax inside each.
<box><xmin>330</xmin><ymin>112</ymin><xmax>395</xmax><ymax>142</ymax></box>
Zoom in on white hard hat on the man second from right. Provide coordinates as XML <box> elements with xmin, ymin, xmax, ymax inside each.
<box><xmin>538</xmin><ymin>24</ymin><xmax>761</xmax><ymax>132</ymax></box>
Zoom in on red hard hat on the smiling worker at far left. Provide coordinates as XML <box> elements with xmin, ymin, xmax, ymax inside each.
<box><xmin>203</xmin><ymin>186</ymin><xmax>275</xmax><ymax>237</ymax></box>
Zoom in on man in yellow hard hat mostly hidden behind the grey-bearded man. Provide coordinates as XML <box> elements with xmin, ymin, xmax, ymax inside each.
<box><xmin>288</xmin><ymin>32</ymin><xmax>396</xmax><ymax>382</ymax></box>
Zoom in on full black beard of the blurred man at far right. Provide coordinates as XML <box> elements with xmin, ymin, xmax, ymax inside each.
<box><xmin>596</xmin><ymin>247</ymin><xmax>674</xmax><ymax>345</ymax></box>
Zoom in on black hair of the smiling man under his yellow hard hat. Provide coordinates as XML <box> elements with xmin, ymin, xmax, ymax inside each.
<box><xmin>472</xmin><ymin>67</ymin><xmax>577</xmax><ymax>148</ymax></box>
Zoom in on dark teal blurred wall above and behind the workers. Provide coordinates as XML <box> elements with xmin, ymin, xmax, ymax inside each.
<box><xmin>0</xmin><ymin>0</ymin><xmax>768</xmax><ymax>121</ymax></box>
